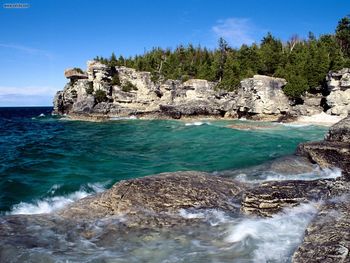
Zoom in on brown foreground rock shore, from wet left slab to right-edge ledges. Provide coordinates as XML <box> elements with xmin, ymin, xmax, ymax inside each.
<box><xmin>0</xmin><ymin>117</ymin><xmax>350</xmax><ymax>263</ymax></box>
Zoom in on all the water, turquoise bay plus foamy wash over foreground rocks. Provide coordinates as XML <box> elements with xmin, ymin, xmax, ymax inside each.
<box><xmin>0</xmin><ymin>108</ymin><xmax>332</xmax><ymax>262</ymax></box>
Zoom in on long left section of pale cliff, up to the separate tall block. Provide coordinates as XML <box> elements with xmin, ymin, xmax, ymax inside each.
<box><xmin>54</xmin><ymin>61</ymin><xmax>238</xmax><ymax>118</ymax></box>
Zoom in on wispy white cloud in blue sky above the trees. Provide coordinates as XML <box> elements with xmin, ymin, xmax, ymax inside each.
<box><xmin>212</xmin><ymin>18</ymin><xmax>257</xmax><ymax>47</ymax></box>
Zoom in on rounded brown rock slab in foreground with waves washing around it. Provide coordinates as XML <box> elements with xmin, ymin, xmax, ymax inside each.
<box><xmin>58</xmin><ymin>171</ymin><xmax>246</xmax><ymax>226</ymax></box>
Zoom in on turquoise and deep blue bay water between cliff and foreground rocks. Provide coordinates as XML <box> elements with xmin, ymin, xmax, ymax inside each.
<box><xmin>0</xmin><ymin>108</ymin><xmax>326</xmax><ymax>213</ymax></box>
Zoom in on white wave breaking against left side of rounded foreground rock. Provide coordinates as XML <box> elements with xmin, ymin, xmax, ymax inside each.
<box><xmin>6</xmin><ymin>183</ymin><xmax>107</xmax><ymax>215</ymax></box>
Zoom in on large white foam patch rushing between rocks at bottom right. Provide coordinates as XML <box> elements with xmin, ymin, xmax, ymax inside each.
<box><xmin>225</xmin><ymin>203</ymin><xmax>317</xmax><ymax>262</ymax></box>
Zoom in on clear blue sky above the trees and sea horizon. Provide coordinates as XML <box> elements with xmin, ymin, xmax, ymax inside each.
<box><xmin>0</xmin><ymin>0</ymin><xmax>350</xmax><ymax>106</ymax></box>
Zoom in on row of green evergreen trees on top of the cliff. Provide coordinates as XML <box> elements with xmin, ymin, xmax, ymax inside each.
<box><xmin>95</xmin><ymin>16</ymin><xmax>350</xmax><ymax>98</ymax></box>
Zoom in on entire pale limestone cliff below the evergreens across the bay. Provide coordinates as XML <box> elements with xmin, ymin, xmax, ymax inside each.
<box><xmin>54</xmin><ymin>61</ymin><xmax>350</xmax><ymax>120</ymax></box>
